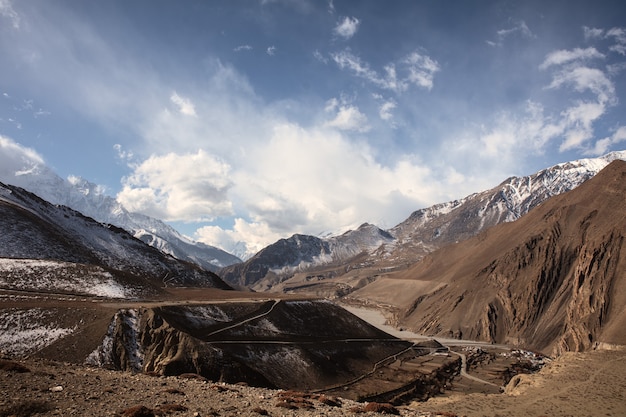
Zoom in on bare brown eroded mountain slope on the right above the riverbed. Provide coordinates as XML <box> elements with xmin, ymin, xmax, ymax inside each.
<box><xmin>353</xmin><ymin>161</ymin><xmax>626</xmax><ymax>354</ymax></box>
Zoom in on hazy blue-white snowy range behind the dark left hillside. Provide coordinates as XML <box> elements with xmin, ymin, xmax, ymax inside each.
<box><xmin>0</xmin><ymin>165</ymin><xmax>241</xmax><ymax>271</ymax></box>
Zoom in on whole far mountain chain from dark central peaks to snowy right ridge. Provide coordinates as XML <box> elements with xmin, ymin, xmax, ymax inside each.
<box><xmin>220</xmin><ymin>151</ymin><xmax>626</xmax><ymax>290</ymax></box>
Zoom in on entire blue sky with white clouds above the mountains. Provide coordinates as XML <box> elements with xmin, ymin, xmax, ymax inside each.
<box><xmin>0</xmin><ymin>0</ymin><xmax>626</xmax><ymax>252</ymax></box>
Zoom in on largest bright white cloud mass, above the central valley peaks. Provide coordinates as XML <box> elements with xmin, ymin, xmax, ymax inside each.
<box><xmin>188</xmin><ymin>123</ymin><xmax>442</xmax><ymax>255</ymax></box>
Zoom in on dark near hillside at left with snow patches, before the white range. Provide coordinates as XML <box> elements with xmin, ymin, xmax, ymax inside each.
<box><xmin>0</xmin><ymin>183</ymin><xmax>229</xmax><ymax>298</ymax></box>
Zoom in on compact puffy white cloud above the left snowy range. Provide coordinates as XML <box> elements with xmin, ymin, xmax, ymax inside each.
<box><xmin>117</xmin><ymin>150</ymin><xmax>232</xmax><ymax>221</ymax></box>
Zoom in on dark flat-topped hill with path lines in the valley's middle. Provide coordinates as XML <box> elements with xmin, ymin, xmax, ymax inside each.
<box><xmin>87</xmin><ymin>301</ymin><xmax>411</xmax><ymax>389</ymax></box>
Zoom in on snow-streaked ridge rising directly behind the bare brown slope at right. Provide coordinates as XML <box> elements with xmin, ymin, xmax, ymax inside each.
<box><xmin>378</xmin><ymin>151</ymin><xmax>626</xmax><ymax>263</ymax></box>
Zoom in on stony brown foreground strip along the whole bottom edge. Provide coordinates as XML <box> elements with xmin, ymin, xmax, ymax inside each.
<box><xmin>0</xmin><ymin>351</ymin><xmax>626</xmax><ymax>417</ymax></box>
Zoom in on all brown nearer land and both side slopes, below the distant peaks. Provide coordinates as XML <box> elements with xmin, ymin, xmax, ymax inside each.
<box><xmin>0</xmin><ymin>161</ymin><xmax>626</xmax><ymax>417</ymax></box>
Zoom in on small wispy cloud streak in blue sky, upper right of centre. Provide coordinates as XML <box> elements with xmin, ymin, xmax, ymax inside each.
<box><xmin>331</xmin><ymin>49</ymin><xmax>440</xmax><ymax>94</ymax></box>
